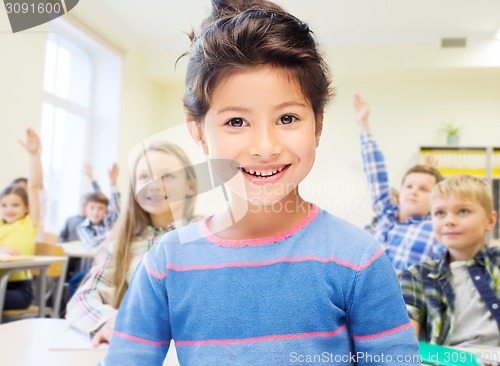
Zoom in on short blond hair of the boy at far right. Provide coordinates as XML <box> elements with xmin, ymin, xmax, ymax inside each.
<box><xmin>431</xmin><ymin>174</ymin><xmax>493</xmax><ymax>215</ymax></box>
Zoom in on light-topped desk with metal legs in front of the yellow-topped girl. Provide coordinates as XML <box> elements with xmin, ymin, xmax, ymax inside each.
<box><xmin>0</xmin><ymin>255</ymin><xmax>68</xmax><ymax>323</ymax></box>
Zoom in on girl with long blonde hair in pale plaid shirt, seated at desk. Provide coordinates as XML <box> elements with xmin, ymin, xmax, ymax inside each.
<box><xmin>66</xmin><ymin>142</ymin><xmax>197</xmax><ymax>346</ymax></box>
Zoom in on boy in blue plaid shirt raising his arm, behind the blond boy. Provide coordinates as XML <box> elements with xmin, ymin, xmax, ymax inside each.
<box><xmin>354</xmin><ymin>95</ymin><xmax>443</xmax><ymax>274</ymax></box>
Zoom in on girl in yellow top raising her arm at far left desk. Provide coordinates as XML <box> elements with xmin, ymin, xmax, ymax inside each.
<box><xmin>0</xmin><ymin>128</ymin><xmax>42</xmax><ymax>310</ymax></box>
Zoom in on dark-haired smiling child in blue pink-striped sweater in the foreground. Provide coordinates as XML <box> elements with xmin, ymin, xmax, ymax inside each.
<box><xmin>101</xmin><ymin>0</ymin><xmax>420</xmax><ymax>366</ymax></box>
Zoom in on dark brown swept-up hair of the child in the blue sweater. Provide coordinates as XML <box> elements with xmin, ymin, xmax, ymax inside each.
<box><xmin>184</xmin><ymin>0</ymin><xmax>333</xmax><ymax>127</ymax></box>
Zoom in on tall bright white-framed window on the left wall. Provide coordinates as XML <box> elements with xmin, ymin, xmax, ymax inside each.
<box><xmin>41</xmin><ymin>22</ymin><xmax>121</xmax><ymax>233</ymax></box>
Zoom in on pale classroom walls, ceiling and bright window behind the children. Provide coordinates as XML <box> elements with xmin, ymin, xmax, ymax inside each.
<box><xmin>0</xmin><ymin>0</ymin><xmax>500</xmax><ymax>234</ymax></box>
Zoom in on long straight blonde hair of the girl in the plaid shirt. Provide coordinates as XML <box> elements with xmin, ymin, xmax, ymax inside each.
<box><xmin>111</xmin><ymin>142</ymin><xmax>197</xmax><ymax>309</ymax></box>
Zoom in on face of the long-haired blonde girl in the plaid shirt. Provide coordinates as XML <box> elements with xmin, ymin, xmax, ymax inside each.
<box><xmin>134</xmin><ymin>151</ymin><xmax>194</xmax><ymax>218</ymax></box>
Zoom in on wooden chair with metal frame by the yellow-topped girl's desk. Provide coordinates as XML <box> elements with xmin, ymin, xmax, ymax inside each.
<box><xmin>2</xmin><ymin>243</ymin><xmax>67</xmax><ymax>319</ymax></box>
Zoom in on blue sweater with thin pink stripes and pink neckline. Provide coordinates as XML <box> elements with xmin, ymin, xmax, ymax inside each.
<box><xmin>97</xmin><ymin>206</ymin><xmax>420</xmax><ymax>366</ymax></box>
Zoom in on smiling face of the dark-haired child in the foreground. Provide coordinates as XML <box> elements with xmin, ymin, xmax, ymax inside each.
<box><xmin>195</xmin><ymin>67</ymin><xmax>322</xmax><ymax>205</ymax></box>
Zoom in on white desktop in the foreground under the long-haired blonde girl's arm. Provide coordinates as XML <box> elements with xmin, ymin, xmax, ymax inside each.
<box><xmin>0</xmin><ymin>318</ymin><xmax>179</xmax><ymax>366</ymax></box>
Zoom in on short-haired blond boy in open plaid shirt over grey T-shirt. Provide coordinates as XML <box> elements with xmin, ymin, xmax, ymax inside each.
<box><xmin>401</xmin><ymin>175</ymin><xmax>500</xmax><ymax>347</ymax></box>
